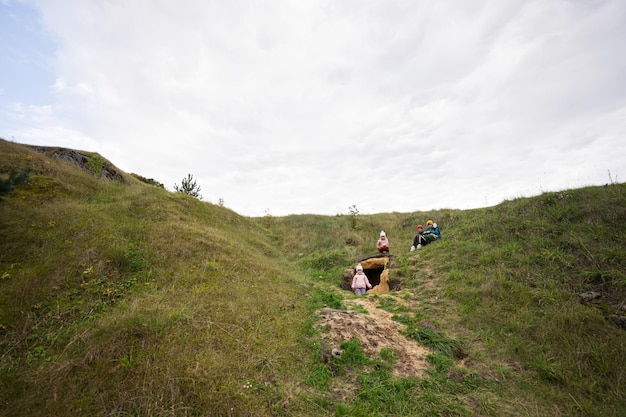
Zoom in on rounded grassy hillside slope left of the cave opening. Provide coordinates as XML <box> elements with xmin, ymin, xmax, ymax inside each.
<box><xmin>0</xmin><ymin>142</ymin><xmax>314</xmax><ymax>416</ymax></box>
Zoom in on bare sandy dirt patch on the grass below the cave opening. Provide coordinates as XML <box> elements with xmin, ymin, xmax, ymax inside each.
<box><xmin>319</xmin><ymin>296</ymin><xmax>430</xmax><ymax>377</ymax></box>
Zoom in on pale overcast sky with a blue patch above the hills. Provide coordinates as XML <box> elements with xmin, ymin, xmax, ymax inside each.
<box><xmin>0</xmin><ymin>0</ymin><xmax>626</xmax><ymax>216</ymax></box>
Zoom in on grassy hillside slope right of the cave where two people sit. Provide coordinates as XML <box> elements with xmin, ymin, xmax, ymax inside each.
<box><xmin>266</xmin><ymin>183</ymin><xmax>626</xmax><ymax>416</ymax></box>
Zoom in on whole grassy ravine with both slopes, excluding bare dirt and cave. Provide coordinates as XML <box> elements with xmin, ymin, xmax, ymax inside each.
<box><xmin>0</xmin><ymin>136</ymin><xmax>626</xmax><ymax>417</ymax></box>
